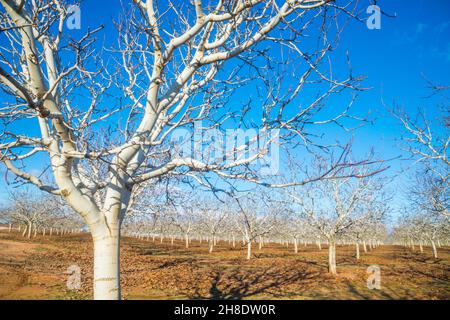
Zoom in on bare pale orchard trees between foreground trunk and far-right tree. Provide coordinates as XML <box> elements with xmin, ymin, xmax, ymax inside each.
<box><xmin>120</xmin><ymin>168</ymin><xmax>388</xmax><ymax>274</ymax></box>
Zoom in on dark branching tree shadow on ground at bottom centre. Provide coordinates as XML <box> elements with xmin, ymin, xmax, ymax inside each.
<box><xmin>190</xmin><ymin>267</ymin><xmax>318</xmax><ymax>300</ymax></box>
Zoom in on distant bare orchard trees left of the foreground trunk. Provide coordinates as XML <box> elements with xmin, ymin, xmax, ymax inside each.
<box><xmin>0</xmin><ymin>189</ymin><xmax>84</xmax><ymax>239</ymax></box>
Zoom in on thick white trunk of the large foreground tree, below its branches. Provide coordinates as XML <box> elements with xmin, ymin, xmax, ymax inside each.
<box><xmin>93</xmin><ymin>227</ymin><xmax>121</xmax><ymax>300</ymax></box>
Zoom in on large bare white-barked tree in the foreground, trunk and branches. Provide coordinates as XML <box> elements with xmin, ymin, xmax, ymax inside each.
<box><xmin>0</xmin><ymin>0</ymin><xmax>372</xmax><ymax>299</ymax></box>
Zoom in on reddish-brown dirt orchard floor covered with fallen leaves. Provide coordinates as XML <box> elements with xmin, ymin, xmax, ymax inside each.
<box><xmin>0</xmin><ymin>231</ymin><xmax>450</xmax><ymax>300</ymax></box>
